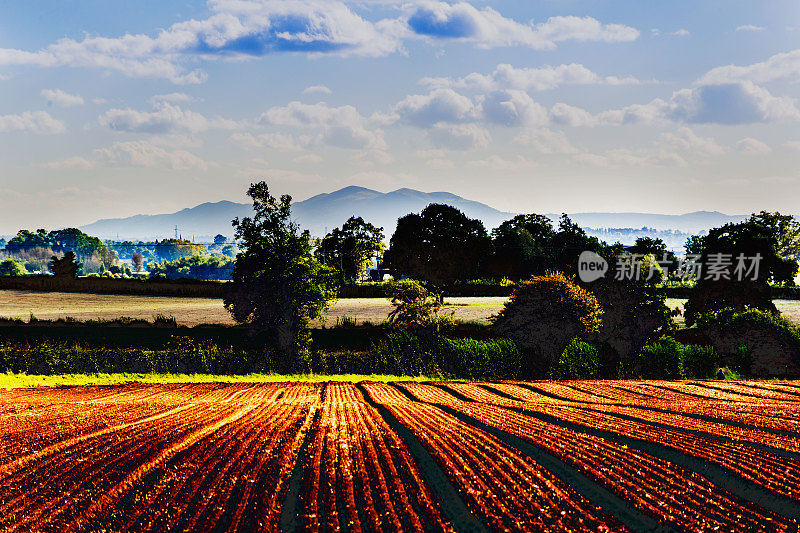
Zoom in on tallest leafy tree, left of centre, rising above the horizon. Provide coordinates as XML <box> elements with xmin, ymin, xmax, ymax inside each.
<box><xmin>225</xmin><ymin>181</ymin><xmax>337</xmax><ymax>371</ymax></box>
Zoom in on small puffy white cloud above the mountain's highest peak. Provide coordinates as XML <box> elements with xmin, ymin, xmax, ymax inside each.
<box><xmin>258</xmin><ymin>102</ymin><xmax>386</xmax><ymax>150</ymax></box>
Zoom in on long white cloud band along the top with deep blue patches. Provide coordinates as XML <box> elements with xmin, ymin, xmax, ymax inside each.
<box><xmin>0</xmin><ymin>0</ymin><xmax>639</xmax><ymax>84</ymax></box>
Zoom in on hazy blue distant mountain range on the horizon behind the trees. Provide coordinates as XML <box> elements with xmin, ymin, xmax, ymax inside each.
<box><xmin>80</xmin><ymin>186</ymin><xmax>745</xmax><ymax>242</ymax></box>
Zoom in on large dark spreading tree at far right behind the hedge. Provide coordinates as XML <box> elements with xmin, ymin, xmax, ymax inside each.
<box><xmin>685</xmin><ymin>215</ymin><xmax>798</xmax><ymax>326</ymax></box>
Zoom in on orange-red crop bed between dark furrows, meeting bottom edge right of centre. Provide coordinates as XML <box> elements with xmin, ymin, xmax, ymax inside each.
<box><xmin>365</xmin><ymin>384</ymin><xmax>625</xmax><ymax>531</ymax></box>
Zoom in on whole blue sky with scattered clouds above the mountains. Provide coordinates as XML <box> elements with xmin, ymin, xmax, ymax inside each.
<box><xmin>0</xmin><ymin>0</ymin><xmax>800</xmax><ymax>234</ymax></box>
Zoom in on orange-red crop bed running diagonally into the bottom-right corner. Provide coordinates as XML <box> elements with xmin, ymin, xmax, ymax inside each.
<box><xmin>398</xmin><ymin>383</ymin><xmax>796</xmax><ymax>531</ymax></box>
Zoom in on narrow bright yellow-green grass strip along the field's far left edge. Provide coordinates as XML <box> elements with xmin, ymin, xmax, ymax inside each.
<box><xmin>0</xmin><ymin>373</ymin><xmax>430</xmax><ymax>389</ymax></box>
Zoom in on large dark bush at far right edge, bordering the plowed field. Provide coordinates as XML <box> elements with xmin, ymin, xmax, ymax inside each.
<box><xmin>697</xmin><ymin>308</ymin><xmax>800</xmax><ymax>378</ymax></box>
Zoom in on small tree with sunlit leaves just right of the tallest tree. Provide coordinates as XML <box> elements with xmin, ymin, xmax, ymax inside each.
<box><xmin>316</xmin><ymin>217</ymin><xmax>384</xmax><ymax>283</ymax></box>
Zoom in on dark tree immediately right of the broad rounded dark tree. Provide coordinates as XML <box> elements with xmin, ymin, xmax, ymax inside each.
<box><xmin>489</xmin><ymin>214</ymin><xmax>556</xmax><ymax>281</ymax></box>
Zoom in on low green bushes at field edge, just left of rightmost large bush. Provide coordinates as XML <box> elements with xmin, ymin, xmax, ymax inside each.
<box><xmin>622</xmin><ymin>337</ymin><xmax>720</xmax><ymax>379</ymax></box>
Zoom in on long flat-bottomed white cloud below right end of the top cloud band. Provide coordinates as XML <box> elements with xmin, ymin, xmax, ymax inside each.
<box><xmin>420</xmin><ymin>63</ymin><xmax>640</xmax><ymax>92</ymax></box>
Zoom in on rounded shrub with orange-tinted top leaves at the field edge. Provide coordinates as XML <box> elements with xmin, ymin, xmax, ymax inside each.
<box><xmin>492</xmin><ymin>272</ymin><xmax>603</xmax><ymax>377</ymax></box>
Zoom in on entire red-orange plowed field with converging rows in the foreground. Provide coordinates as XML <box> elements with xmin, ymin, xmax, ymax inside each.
<box><xmin>0</xmin><ymin>381</ymin><xmax>800</xmax><ymax>532</ymax></box>
